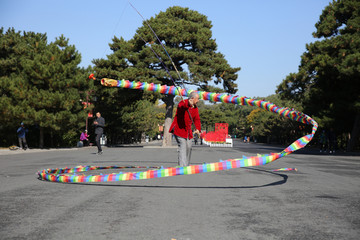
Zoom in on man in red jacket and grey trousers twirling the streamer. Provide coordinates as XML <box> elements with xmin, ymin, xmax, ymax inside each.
<box><xmin>169</xmin><ymin>91</ymin><xmax>201</xmax><ymax>167</ymax></box>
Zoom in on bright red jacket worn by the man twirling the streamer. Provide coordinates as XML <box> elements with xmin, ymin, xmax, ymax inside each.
<box><xmin>169</xmin><ymin>99</ymin><xmax>201</xmax><ymax>139</ymax></box>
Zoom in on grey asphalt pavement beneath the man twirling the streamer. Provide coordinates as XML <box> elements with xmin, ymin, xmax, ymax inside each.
<box><xmin>0</xmin><ymin>142</ymin><xmax>360</xmax><ymax>240</ymax></box>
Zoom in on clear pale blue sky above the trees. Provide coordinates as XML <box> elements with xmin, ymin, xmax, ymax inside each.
<box><xmin>0</xmin><ymin>0</ymin><xmax>330</xmax><ymax>97</ymax></box>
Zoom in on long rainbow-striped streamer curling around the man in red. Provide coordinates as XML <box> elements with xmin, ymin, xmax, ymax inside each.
<box><xmin>38</xmin><ymin>78</ymin><xmax>318</xmax><ymax>183</ymax></box>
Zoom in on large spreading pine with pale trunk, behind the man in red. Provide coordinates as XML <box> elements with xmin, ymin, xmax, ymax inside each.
<box><xmin>94</xmin><ymin>7</ymin><xmax>240</xmax><ymax>145</ymax></box>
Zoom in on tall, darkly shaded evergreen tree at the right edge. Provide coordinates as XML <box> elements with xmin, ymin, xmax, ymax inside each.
<box><xmin>277</xmin><ymin>0</ymin><xmax>360</xmax><ymax>150</ymax></box>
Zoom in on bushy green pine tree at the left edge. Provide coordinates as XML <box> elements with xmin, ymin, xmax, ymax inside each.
<box><xmin>0</xmin><ymin>29</ymin><xmax>91</xmax><ymax>147</ymax></box>
